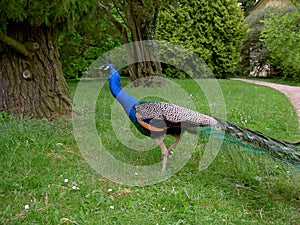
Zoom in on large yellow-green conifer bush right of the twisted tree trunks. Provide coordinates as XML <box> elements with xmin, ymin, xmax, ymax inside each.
<box><xmin>157</xmin><ymin>0</ymin><xmax>245</xmax><ymax>78</ymax></box>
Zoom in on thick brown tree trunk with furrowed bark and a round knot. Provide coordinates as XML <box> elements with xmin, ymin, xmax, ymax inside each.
<box><xmin>0</xmin><ymin>24</ymin><xmax>71</xmax><ymax>119</ymax></box>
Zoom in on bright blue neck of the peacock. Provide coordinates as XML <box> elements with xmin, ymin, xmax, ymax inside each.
<box><xmin>108</xmin><ymin>68</ymin><xmax>138</xmax><ymax>116</ymax></box>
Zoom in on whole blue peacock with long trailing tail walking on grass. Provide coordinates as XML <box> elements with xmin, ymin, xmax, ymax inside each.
<box><xmin>100</xmin><ymin>64</ymin><xmax>300</xmax><ymax>171</ymax></box>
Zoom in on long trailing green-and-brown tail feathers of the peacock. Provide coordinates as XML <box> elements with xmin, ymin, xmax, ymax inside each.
<box><xmin>202</xmin><ymin>119</ymin><xmax>300</xmax><ymax>171</ymax></box>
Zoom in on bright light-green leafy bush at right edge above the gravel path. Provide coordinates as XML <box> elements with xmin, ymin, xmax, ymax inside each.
<box><xmin>262</xmin><ymin>3</ymin><xmax>300</xmax><ymax>80</ymax></box>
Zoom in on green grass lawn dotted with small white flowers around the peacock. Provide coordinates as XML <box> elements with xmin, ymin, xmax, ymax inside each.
<box><xmin>0</xmin><ymin>79</ymin><xmax>300</xmax><ymax>225</ymax></box>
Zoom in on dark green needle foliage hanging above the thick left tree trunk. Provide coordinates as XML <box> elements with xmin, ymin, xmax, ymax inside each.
<box><xmin>0</xmin><ymin>0</ymin><xmax>96</xmax><ymax>32</ymax></box>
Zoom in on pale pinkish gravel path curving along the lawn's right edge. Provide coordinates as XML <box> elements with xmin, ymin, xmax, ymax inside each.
<box><xmin>232</xmin><ymin>78</ymin><xmax>300</xmax><ymax>123</ymax></box>
